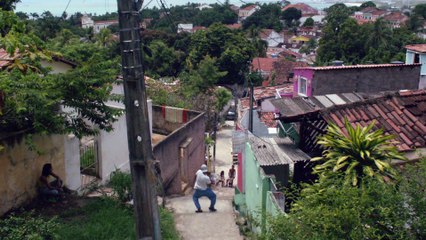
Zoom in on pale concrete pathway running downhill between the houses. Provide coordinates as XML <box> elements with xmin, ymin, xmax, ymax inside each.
<box><xmin>167</xmin><ymin>121</ymin><xmax>244</xmax><ymax>240</ymax></box>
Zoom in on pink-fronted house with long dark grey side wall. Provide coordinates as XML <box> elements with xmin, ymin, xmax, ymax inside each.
<box><xmin>294</xmin><ymin>63</ymin><xmax>421</xmax><ymax>97</ymax></box>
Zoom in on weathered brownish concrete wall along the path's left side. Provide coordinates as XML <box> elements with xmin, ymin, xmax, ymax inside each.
<box><xmin>152</xmin><ymin>106</ymin><xmax>206</xmax><ymax>194</ymax></box>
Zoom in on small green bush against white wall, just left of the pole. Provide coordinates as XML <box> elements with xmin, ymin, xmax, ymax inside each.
<box><xmin>109</xmin><ymin>169</ymin><xmax>132</xmax><ymax>202</ymax></box>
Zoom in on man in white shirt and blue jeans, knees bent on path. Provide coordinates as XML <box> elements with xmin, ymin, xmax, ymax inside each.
<box><xmin>192</xmin><ymin>164</ymin><xmax>216</xmax><ymax>213</ymax></box>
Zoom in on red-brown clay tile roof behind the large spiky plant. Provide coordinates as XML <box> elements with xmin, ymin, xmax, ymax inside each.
<box><xmin>321</xmin><ymin>90</ymin><xmax>426</xmax><ymax>151</ymax></box>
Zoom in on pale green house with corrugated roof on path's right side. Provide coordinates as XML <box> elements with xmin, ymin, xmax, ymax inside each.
<box><xmin>234</xmin><ymin>133</ymin><xmax>310</xmax><ymax>232</ymax></box>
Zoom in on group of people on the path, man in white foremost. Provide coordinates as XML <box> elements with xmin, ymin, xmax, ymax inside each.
<box><xmin>192</xmin><ymin>164</ymin><xmax>235</xmax><ymax>213</ymax></box>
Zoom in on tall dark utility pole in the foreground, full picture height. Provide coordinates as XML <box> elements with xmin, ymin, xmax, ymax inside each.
<box><xmin>117</xmin><ymin>0</ymin><xmax>161</xmax><ymax>240</ymax></box>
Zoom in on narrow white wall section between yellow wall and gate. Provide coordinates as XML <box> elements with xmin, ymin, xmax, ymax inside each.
<box><xmin>64</xmin><ymin>134</ymin><xmax>81</xmax><ymax>190</ymax></box>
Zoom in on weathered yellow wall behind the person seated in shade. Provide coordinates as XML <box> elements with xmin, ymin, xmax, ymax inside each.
<box><xmin>0</xmin><ymin>135</ymin><xmax>65</xmax><ymax>216</ymax></box>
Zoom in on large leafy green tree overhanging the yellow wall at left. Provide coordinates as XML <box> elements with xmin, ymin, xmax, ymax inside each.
<box><xmin>0</xmin><ymin>11</ymin><xmax>119</xmax><ymax>137</ymax></box>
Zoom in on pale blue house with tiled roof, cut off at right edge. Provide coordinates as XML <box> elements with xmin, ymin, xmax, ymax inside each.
<box><xmin>405</xmin><ymin>44</ymin><xmax>426</xmax><ymax>89</ymax></box>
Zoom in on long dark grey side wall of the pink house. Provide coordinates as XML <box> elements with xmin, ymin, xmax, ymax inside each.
<box><xmin>312</xmin><ymin>66</ymin><xmax>420</xmax><ymax>95</ymax></box>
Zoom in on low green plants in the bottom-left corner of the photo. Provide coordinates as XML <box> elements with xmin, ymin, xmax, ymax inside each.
<box><xmin>0</xmin><ymin>212</ymin><xmax>59</xmax><ymax>240</ymax></box>
